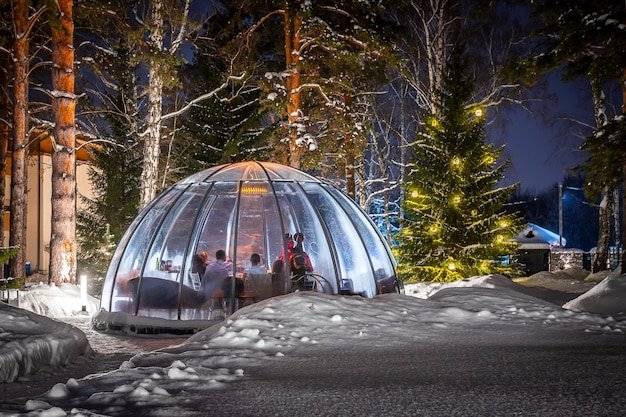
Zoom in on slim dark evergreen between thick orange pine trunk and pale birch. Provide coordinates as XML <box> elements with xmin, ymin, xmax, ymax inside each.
<box><xmin>77</xmin><ymin>42</ymin><xmax>142</xmax><ymax>274</ymax></box>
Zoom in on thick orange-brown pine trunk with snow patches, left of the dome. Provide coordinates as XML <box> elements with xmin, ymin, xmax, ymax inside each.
<box><xmin>50</xmin><ymin>0</ymin><xmax>76</xmax><ymax>285</ymax></box>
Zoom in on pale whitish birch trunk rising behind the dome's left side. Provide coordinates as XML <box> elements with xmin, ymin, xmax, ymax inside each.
<box><xmin>139</xmin><ymin>0</ymin><xmax>163</xmax><ymax>209</ymax></box>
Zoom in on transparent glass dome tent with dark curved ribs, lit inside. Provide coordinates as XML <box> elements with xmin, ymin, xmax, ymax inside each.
<box><xmin>94</xmin><ymin>162</ymin><xmax>402</xmax><ymax>330</ymax></box>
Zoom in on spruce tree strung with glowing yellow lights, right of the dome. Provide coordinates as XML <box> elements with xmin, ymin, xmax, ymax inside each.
<box><xmin>397</xmin><ymin>51</ymin><xmax>521</xmax><ymax>282</ymax></box>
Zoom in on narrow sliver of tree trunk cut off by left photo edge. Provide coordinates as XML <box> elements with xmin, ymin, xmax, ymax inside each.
<box><xmin>0</xmin><ymin>48</ymin><xmax>11</xmax><ymax>278</ymax></box>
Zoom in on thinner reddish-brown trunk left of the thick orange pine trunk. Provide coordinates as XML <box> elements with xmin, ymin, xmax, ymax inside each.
<box><xmin>9</xmin><ymin>0</ymin><xmax>30</xmax><ymax>277</ymax></box>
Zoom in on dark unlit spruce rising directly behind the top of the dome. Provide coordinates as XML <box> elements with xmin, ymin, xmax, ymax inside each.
<box><xmin>177</xmin><ymin>14</ymin><xmax>271</xmax><ymax>175</ymax></box>
